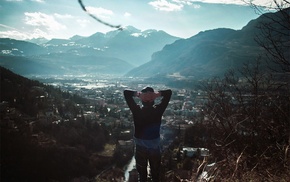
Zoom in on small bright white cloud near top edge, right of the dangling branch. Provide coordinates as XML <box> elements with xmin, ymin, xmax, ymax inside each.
<box><xmin>149</xmin><ymin>0</ymin><xmax>183</xmax><ymax>11</ymax></box>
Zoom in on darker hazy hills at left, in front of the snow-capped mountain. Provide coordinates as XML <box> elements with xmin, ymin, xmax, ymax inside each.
<box><xmin>0</xmin><ymin>39</ymin><xmax>133</xmax><ymax>75</ymax></box>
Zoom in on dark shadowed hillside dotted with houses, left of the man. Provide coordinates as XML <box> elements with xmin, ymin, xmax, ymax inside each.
<box><xmin>0</xmin><ymin>67</ymin><xmax>111</xmax><ymax>181</ymax></box>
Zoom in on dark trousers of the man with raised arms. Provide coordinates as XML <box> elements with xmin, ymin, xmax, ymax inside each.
<box><xmin>135</xmin><ymin>145</ymin><xmax>161</xmax><ymax>182</ymax></box>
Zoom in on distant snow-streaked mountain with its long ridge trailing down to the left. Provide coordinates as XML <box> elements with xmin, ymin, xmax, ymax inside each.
<box><xmin>37</xmin><ymin>26</ymin><xmax>179</xmax><ymax>66</ymax></box>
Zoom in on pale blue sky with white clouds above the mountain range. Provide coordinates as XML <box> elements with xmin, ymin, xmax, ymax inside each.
<box><xmin>0</xmin><ymin>0</ymin><xmax>273</xmax><ymax>40</ymax></box>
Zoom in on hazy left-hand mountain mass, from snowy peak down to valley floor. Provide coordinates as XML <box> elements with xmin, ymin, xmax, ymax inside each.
<box><xmin>0</xmin><ymin>26</ymin><xmax>179</xmax><ymax>75</ymax></box>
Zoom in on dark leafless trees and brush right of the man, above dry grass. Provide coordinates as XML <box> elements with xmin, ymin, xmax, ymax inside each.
<box><xmin>204</xmin><ymin>60</ymin><xmax>290</xmax><ymax>179</ymax></box>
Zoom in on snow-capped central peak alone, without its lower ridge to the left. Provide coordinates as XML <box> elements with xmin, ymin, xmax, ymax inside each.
<box><xmin>71</xmin><ymin>26</ymin><xmax>180</xmax><ymax>66</ymax></box>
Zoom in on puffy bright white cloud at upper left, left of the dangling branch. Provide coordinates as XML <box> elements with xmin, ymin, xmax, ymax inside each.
<box><xmin>24</xmin><ymin>12</ymin><xmax>66</xmax><ymax>31</ymax></box>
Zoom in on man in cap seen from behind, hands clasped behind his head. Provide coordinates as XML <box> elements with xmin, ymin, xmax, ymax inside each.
<box><xmin>124</xmin><ymin>87</ymin><xmax>172</xmax><ymax>182</ymax></box>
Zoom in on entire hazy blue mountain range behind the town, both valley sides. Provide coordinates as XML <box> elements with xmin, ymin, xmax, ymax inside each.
<box><xmin>0</xmin><ymin>8</ymin><xmax>290</xmax><ymax>78</ymax></box>
